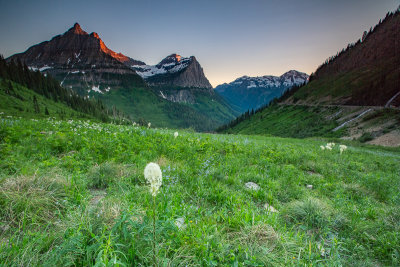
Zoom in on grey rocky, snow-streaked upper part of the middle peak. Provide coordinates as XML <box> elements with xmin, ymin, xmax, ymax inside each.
<box><xmin>131</xmin><ymin>54</ymin><xmax>212</xmax><ymax>89</ymax></box>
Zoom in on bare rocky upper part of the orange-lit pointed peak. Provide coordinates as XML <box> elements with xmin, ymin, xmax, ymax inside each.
<box><xmin>7</xmin><ymin>23</ymin><xmax>144</xmax><ymax>94</ymax></box>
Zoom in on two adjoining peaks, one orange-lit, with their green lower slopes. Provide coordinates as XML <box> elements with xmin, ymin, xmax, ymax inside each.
<box><xmin>7</xmin><ymin>23</ymin><xmax>238</xmax><ymax>131</ymax></box>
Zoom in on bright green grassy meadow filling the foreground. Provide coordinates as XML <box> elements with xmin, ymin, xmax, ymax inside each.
<box><xmin>0</xmin><ymin>117</ymin><xmax>400</xmax><ymax>266</ymax></box>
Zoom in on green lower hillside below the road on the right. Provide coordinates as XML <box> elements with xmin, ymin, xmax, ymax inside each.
<box><xmin>217</xmin><ymin>104</ymin><xmax>400</xmax><ymax>146</ymax></box>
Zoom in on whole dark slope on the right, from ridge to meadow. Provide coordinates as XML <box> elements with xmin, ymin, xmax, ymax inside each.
<box><xmin>219</xmin><ymin>8</ymin><xmax>400</xmax><ymax>146</ymax></box>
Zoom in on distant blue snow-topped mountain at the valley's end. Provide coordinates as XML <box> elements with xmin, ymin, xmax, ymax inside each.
<box><xmin>215</xmin><ymin>70</ymin><xmax>309</xmax><ymax>112</ymax></box>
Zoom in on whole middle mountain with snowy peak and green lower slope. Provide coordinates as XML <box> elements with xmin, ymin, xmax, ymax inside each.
<box><xmin>131</xmin><ymin>54</ymin><xmax>239</xmax><ymax>122</ymax></box>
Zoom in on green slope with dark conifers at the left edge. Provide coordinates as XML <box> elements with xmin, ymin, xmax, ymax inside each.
<box><xmin>0</xmin><ymin>55</ymin><xmax>129</xmax><ymax>122</ymax></box>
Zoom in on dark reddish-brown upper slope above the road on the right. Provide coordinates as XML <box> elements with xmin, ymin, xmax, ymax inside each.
<box><xmin>286</xmin><ymin>7</ymin><xmax>400</xmax><ymax>106</ymax></box>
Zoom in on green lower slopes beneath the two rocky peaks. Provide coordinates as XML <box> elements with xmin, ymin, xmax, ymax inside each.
<box><xmin>100</xmin><ymin>87</ymin><xmax>238</xmax><ymax>131</ymax></box>
